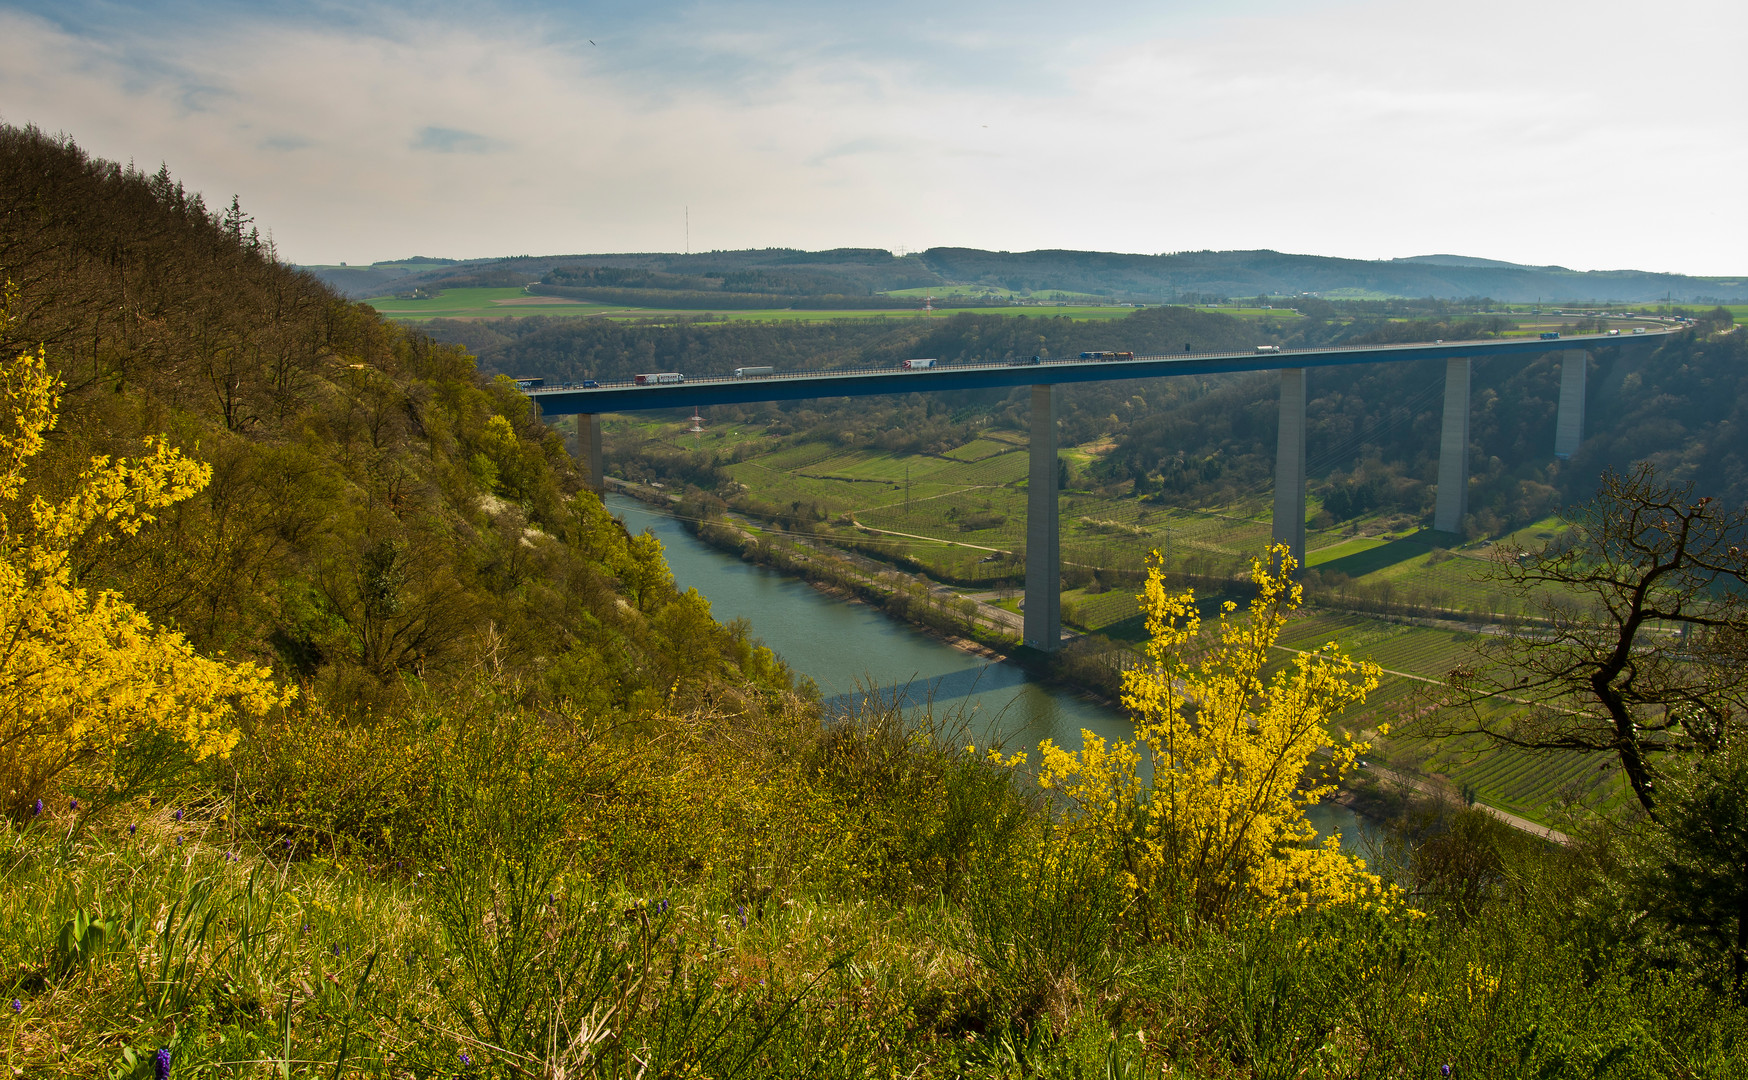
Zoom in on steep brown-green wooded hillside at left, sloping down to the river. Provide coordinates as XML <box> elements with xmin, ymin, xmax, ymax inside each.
<box><xmin>0</xmin><ymin>128</ymin><xmax>787</xmax><ymax>710</ymax></box>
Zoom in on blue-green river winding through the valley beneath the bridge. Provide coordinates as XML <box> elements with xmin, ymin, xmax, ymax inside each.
<box><xmin>607</xmin><ymin>495</ymin><xmax>1360</xmax><ymax>842</ymax></box>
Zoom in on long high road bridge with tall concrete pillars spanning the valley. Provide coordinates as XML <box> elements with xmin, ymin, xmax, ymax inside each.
<box><xmin>528</xmin><ymin>330</ymin><xmax>1675</xmax><ymax>650</ymax></box>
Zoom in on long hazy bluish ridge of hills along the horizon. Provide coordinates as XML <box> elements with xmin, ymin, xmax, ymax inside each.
<box><xmin>304</xmin><ymin>248</ymin><xmax>1748</xmax><ymax>306</ymax></box>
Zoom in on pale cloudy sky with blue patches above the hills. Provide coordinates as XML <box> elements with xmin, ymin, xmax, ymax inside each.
<box><xmin>0</xmin><ymin>0</ymin><xmax>1748</xmax><ymax>274</ymax></box>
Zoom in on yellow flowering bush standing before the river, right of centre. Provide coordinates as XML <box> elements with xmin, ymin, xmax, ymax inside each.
<box><xmin>1040</xmin><ymin>545</ymin><xmax>1397</xmax><ymax>931</ymax></box>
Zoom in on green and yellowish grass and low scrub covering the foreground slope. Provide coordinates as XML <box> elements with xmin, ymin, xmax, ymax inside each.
<box><xmin>0</xmin><ymin>688</ymin><xmax>1748</xmax><ymax>1080</ymax></box>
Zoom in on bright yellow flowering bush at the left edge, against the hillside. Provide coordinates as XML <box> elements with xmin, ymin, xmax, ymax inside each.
<box><xmin>0</xmin><ymin>350</ymin><xmax>294</xmax><ymax>813</ymax></box>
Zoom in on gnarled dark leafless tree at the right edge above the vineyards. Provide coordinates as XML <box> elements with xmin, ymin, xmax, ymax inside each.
<box><xmin>1433</xmin><ymin>461</ymin><xmax>1748</xmax><ymax>813</ymax></box>
